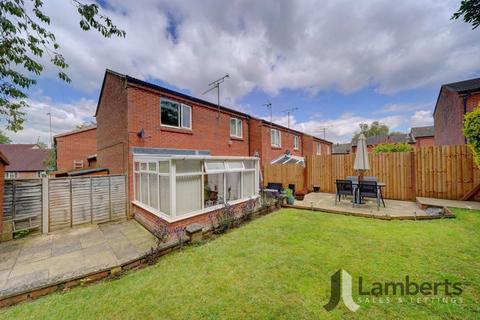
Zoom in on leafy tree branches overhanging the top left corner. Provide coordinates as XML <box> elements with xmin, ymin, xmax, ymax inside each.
<box><xmin>0</xmin><ymin>0</ymin><xmax>125</xmax><ymax>132</ymax></box>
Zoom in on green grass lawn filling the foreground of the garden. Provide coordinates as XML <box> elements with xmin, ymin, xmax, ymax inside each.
<box><xmin>0</xmin><ymin>210</ymin><xmax>480</xmax><ymax>319</ymax></box>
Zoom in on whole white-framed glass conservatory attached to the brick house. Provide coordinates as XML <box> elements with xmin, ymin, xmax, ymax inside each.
<box><xmin>133</xmin><ymin>154</ymin><xmax>260</xmax><ymax>222</ymax></box>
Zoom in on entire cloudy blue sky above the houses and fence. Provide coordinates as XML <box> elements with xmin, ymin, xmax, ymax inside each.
<box><xmin>0</xmin><ymin>0</ymin><xmax>480</xmax><ymax>143</ymax></box>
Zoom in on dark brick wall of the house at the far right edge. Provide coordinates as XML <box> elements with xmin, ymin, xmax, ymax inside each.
<box><xmin>434</xmin><ymin>88</ymin><xmax>480</xmax><ymax>145</ymax></box>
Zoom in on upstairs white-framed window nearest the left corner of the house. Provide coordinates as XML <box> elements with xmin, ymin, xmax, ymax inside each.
<box><xmin>160</xmin><ymin>98</ymin><xmax>192</xmax><ymax>129</ymax></box>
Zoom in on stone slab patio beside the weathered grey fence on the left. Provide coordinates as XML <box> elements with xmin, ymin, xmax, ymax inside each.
<box><xmin>0</xmin><ymin>220</ymin><xmax>155</xmax><ymax>299</ymax></box>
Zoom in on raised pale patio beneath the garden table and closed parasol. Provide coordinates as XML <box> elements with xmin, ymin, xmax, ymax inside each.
<box><xmin>294</xmin><ymin>192</ymin><xmax>448</xmax><ymax>220</ymax></box>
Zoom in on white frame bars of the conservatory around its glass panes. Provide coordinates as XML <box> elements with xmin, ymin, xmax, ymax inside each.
<box><xmin>132</xmin><ymin>154</ymin><xmax>260</xmax><ymax>222</ymax></box>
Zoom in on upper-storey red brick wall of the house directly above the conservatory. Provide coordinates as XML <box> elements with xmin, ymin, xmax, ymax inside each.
<box><xmin>124</xmin><ymin>86</ymin><xmax>249</xmax><ymax>156</ymax></box>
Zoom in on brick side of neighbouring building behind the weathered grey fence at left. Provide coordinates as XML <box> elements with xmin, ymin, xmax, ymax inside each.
<box><xmin>53</xmin><ymin>126</ymin><xmax>97</xmax><ymax>172</ymax></box>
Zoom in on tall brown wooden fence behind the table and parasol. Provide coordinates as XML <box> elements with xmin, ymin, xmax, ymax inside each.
<box><xmin>264</xmin><ymin>145</ymin><xmax>480</xmax><ymax>200</ymax></box>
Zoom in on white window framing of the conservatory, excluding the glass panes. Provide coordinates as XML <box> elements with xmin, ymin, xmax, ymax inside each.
<box><xmin>132</xmin><ymin>155</ymin><xmax>260</xmax><ymax>222</ymax></box>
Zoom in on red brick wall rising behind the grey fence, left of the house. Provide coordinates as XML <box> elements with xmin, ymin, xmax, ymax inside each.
<box><xmin>55</xmin><ymin>128</ymin><xmax>97</xmax><ymax>171</ymax></box>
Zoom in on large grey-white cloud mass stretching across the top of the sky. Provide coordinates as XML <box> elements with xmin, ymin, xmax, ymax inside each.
<box><xmin>35</xmin><ymin>0</ymin><xmax>480</xmax><ymax>104</ymax></box>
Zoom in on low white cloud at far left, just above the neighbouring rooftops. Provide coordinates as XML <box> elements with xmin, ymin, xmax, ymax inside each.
<box><xmin>3</xmin><ymin>97</ymin><xmax>97</xmax><ymax>144</ymax></box>
